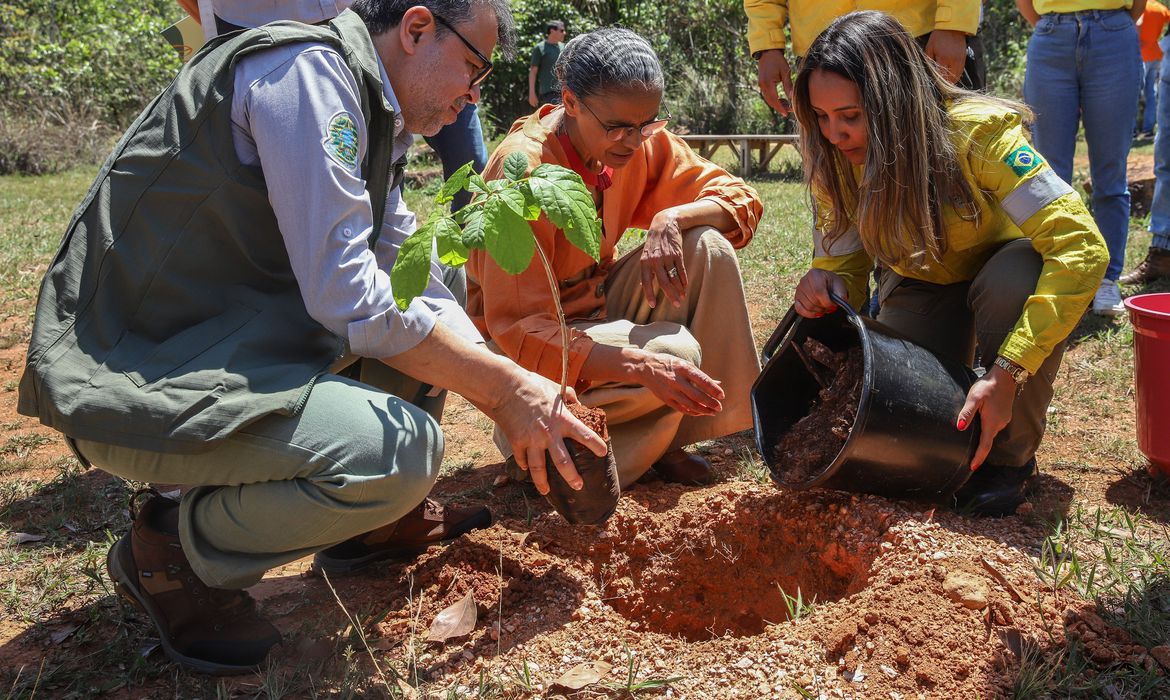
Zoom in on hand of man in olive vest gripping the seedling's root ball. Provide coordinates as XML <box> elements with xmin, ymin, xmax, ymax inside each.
<box><xmin>483</xmin><ymin>368</ymin><xmax>607</xmax><ymax>495</ymax></box>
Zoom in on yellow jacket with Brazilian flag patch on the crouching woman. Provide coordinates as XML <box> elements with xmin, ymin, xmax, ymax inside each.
<box><xmin>812</xmin><ymin>99</ymin><xmax>1109</xmax><ymax>372</ymax></box>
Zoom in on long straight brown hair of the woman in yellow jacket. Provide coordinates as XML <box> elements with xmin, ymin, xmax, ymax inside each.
<box><xmin>793</xmin><ymin>11</ymin><xmax>1031</xmax><ymax>267</ymax></box>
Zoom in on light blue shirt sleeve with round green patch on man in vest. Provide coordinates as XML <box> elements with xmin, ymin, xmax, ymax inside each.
<box><xmin>232</xmin><ymin>43</ymin><xmax>482</xmax><ymax>358</ymax></box>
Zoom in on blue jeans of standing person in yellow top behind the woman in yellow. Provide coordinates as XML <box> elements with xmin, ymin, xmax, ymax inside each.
<box><xmin>1024</xmin><ymin>9</ymin><xmax>1142</xmax><ymax>281</ymax></box>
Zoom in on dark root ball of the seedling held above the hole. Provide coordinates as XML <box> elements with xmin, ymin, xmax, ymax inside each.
<box><xmin>508</xmin><ymin>404</ymin><xmax>621</xmax><ymax>524</ymax></box>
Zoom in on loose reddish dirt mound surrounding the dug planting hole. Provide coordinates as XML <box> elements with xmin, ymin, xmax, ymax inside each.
<box><xmin>313</xmin><ymin>483</ymin><xmax>1065</xmax><ymax>698</ymax></box>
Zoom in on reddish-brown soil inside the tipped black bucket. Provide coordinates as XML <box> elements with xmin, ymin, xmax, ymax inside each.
<box><xmin>773</xmin><ymin>338</ymin><xmax>865</xmax><ymax>483</ymax></box>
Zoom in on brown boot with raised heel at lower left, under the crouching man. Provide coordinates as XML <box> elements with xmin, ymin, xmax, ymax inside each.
<box><xmin>105</xmin><ymin>492</ymin><xmax>281</xmax><ymax>675</ymax></box>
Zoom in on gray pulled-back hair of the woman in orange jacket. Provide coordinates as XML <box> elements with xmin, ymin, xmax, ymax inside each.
<box><xmin>553</xmin><ymin>27</ymin><xmax>665</xmax><ymax>97</ymax></box>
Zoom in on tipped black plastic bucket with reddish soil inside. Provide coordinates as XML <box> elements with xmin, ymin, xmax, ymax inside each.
<box><xmin>751</xmin><ymin>300</ymin><xmax>978</xmax><ymax>503</ymax></box>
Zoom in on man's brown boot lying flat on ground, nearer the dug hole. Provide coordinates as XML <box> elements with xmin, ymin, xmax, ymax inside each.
<box><xmin>312</xmin><ymin>499</ymin><xmax>491</xmax><ymax>575</ymax></box>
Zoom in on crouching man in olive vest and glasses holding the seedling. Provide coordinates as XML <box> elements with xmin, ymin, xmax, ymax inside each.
<box><xmin>19</xmin><ymin>0</ymin><xmax>605</xmax><ymax>673</ymax></box>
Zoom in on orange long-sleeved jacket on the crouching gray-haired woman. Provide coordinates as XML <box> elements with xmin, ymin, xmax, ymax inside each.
<box><xmin>467</xmin><ymin>104</ymin><xmax>764</xmax><ymax>387</ymax></box>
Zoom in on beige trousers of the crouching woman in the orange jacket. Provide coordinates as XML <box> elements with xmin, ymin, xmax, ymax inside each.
<box><xmin>495</xmin><ymin>227</ymin><xmax>759</xmax><ymax>488</ymax></box>
